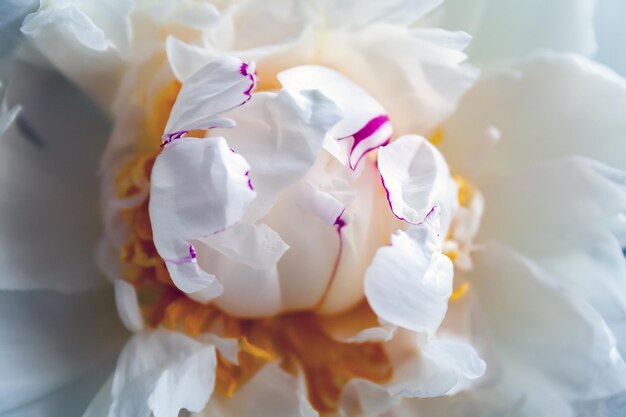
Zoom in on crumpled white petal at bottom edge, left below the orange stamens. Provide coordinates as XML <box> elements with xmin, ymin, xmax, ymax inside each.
<box><xmin>109</xmin><ymin>330</ymin><xmax>217</xmax><ymax>417</ymax></box>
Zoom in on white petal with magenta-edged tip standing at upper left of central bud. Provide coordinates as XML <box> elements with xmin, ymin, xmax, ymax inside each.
<box><xmin>164</xmin><ymin>56</ymin><xmax>256</xmax><ymax>136</ymax></box>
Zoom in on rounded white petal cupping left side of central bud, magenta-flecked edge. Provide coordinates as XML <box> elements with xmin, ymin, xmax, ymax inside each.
<box><xmin>149</xmin><ymin>138</ymin><xmax>255</xmax><ymax>299</ymax></box>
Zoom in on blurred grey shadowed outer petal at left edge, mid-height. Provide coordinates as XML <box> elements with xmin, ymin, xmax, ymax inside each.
<box><xmin>0</xmin><ymin>61</ymin><xmax>109</xmax><ymax>291</ymax></box>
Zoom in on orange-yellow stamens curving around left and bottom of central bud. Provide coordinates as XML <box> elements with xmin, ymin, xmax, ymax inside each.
<box><xmin>116</xmin><ymin>83</ymin><xmax>392</xmax><ymax>414</ymax></box>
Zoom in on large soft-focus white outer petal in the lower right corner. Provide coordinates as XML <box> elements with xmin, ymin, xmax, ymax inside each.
<box><xmin>470</xmin><ymin>244</ymin><xmax>626</xmax><ymax>417</ymax></box>
